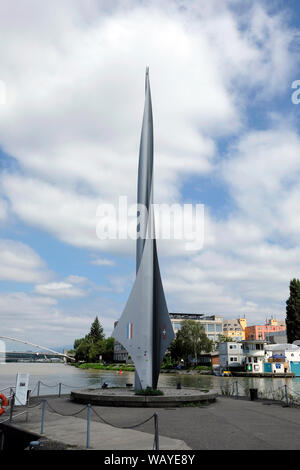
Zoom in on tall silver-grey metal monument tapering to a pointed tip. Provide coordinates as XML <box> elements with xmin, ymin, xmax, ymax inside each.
<box><xmin>113</xmin><ymin>68</ymin><xmax>174</xmax><ymax>389</ymax></box>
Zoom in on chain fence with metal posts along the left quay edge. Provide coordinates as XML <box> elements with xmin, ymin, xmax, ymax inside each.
<box><xmin>0</xmin><ymin>384</ymin><xmax>159</xmax><ymax>450</ymax></box>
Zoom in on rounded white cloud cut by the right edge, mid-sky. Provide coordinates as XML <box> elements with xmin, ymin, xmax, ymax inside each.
<box><xmin>224</xmin><ymin>125</ymin><xmax>300</xmax><ymax>241</ymax></box>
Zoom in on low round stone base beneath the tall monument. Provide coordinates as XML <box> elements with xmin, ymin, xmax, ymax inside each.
<box><xmin>71</xmin><ymin>388</ymin><xmax>218</xmax><ymax>408</ymax></box>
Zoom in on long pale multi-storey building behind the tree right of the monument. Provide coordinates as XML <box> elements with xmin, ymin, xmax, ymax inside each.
<box><xmin>170</xmin><ymin>313</ymin><xmax>223</xmax><ymax>342</ymax></box>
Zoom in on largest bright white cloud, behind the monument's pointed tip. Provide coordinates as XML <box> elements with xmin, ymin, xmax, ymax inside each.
<box><xmin>0</xmin><ymin>1</ymin><xmax>294</xmax><ymax>252</ymax></box>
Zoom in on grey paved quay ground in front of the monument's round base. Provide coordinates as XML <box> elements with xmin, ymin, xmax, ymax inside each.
<box><xmin>4</xmin><ymin>397</ymin><xmax>300</xmax><ymax>450</ymax></box>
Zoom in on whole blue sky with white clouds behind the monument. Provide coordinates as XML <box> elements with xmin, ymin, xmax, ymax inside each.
<box><xmin>0</xmin><ymin>0</ymin><xmax>300</xmax><ymax>347</ymax></box>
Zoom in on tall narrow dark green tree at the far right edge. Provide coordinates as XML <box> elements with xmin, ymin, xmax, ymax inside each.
<box><xmin>285</xmin><ymin>279</ymin><xmax>300</xmax><ymax>343</ymax></box>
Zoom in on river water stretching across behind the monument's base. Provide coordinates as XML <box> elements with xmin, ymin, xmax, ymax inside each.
<box><xmin>0</xmin><ymin>363</ymin><xmax>300</xmax><ymax>399</ymax></box>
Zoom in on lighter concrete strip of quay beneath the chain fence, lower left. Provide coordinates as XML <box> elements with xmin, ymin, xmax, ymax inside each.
<box><xmin>7</xmin><ymin>398</ymin><xmax>189</xmax><ymax>450</ymax></box>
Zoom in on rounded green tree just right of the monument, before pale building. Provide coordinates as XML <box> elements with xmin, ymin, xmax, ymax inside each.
<box><xmin>170</xmin><ymin>320</ymin><xmax>213</xmax><ymax>363</ymax></box>
